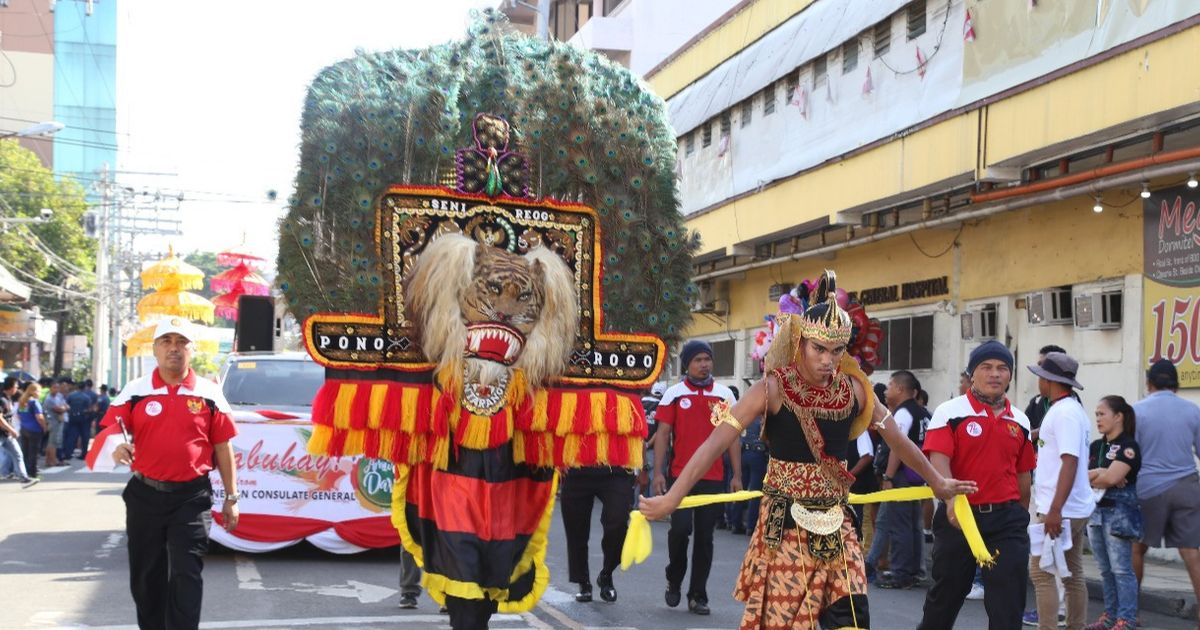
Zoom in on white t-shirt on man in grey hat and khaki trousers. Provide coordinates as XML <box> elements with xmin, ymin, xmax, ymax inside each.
<box><xmin>1033</xmin><ymin>396</ymin><xmax>1096</xmax><ymax>518</ymax></box>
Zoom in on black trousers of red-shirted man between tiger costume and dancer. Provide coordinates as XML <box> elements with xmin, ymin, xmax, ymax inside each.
<box><xmin>667</xmin><ymin>479</ymin><xmax>725</xmax><ymax>604</ymax></box>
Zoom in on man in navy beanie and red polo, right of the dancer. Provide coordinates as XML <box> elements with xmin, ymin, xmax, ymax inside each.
<box><xmin>917</xmin><ymin>341</ymin><xmax>1036</xmax><ymax>630</ymax></box>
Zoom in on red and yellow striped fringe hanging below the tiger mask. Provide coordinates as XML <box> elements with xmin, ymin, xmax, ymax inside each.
<box><xmin>308</xmin><ymin>373</ymin><xmax>646</xmax><ymax>469</ymax></box>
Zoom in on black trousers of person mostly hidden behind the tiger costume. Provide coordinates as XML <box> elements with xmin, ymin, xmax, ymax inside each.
<box><xmin>559</xmin><ymin>468</ymin><xmax>634</xmax><ymax>584</ymax></box>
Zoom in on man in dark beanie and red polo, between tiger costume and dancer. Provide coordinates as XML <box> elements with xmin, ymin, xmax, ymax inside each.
<box><xmin>654</xmin><ymin>340</ymin><xmax>742</xmax><ymax>614</ymax></box>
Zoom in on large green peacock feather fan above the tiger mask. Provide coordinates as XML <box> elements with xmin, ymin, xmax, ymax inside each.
<box><xmin>277</xmin><ymin>10</ymin><xmax>698</xmax><ymax>342</ymax></box>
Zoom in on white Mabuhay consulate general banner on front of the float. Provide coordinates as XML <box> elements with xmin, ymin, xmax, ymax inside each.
<box><xmin>210</xmin><ymin>424</ymin><xmax>394</xmax><ymax>522</ymax></box>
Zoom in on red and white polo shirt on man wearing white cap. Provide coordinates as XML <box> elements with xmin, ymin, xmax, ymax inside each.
<box><xmin>102</xmin><ymin>368</ymin><xmax>238</xmax><ymax>481</ymax></box>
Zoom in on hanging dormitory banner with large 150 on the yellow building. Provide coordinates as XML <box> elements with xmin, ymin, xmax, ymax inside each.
<box><xmin>1142</xmin><ymin>186</ymin><xmax>1200</xmax><ymax>388</ymax></box>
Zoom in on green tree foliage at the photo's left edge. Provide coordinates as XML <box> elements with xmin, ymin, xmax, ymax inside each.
<box><xmin>0</xmin><ymin>139</ymin><xmax>96</xmax><ymax>335</ymax></box>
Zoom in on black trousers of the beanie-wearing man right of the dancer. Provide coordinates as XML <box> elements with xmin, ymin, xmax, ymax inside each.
<box><xmin>917</xmin><ymin>502</ymin><xmax>1030</xmax><ymax>630</ymax></box>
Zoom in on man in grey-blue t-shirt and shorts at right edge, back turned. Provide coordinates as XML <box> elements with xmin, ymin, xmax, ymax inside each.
<box><xmin>1133</xmin><ymin>359</ymin><xmax>1200</xmax><ymax>619</ymax></box>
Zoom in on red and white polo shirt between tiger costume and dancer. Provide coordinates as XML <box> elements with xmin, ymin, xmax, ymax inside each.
<box><xmin>654</xmin><ymin>379</ymin><xmax>734</xmax><ymax>481</ymax></box>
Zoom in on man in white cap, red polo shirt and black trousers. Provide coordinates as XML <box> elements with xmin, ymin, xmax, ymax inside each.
<box><xmin>103</xmin><ymin>318</ymin><xmax>239</xmax><ymax>630</ymax></box>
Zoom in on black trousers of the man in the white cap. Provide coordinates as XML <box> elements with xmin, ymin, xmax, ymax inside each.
<box><xmin>121</xmin><ymin>476</ymin><xmax>212</xmax><ymax>630</ymax></box>
